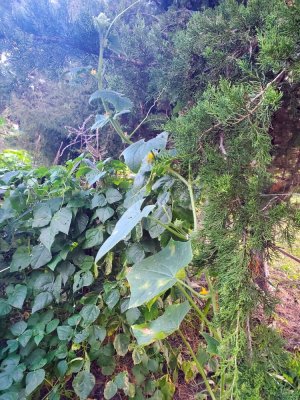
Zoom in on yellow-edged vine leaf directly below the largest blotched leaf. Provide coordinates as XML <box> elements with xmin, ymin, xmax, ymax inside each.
<box><xmin>131</xmin><ymin>301</ymin><xmax>190</xmax><ymax>346</ymax></box>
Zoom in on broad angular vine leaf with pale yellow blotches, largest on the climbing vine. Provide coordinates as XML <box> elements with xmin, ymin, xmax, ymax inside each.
<box><xmin>127</xmin><ymin>239</ymin><xmax>193</xmax><ymax>308</ymax></box>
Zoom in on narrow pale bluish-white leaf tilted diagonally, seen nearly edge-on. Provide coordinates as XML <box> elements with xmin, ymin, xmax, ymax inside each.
<box><xmin>96</xmin><ymin>200</ymin><xmax>155</xmax><ymax>262</ymax></box>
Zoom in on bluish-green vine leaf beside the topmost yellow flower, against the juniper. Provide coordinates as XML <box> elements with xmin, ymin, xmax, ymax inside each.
<box><xmin>122</xmin><ymin>132</ymin><xmax>168</xmax><ymax>172</ymax></box>
